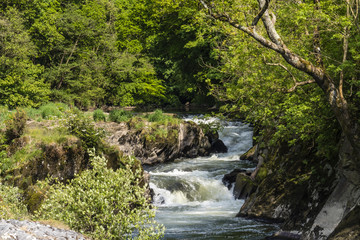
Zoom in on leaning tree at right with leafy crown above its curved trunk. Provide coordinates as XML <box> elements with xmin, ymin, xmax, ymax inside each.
<box><xmin>199</xmin><ymin>0</ymin><xmax>360</xmax><ymax>237</ymax></box>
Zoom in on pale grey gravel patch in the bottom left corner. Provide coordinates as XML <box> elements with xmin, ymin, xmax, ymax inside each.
<box><xmin>0</xmin><ymin>220</ymin><xmax>86</xmax><ymax>240</ymax></box>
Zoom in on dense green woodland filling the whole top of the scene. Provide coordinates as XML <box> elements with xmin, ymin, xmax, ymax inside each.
<box><xmin>0</xmin><ymin>0</ymin><xmax>360</xmax><ymax>238</ymax></box>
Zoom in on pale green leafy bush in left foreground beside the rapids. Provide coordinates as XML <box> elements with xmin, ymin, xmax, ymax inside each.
<box><xmin>38</xmin><ymin>151</ymin><xmax>163</xmax><ymax>239</ymax></box>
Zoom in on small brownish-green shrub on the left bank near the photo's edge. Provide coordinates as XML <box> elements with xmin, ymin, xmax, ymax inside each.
<box><xmin>5</xmin><ymin>109</ymin><xmax>27</xmax><ymax>143</ymax></box>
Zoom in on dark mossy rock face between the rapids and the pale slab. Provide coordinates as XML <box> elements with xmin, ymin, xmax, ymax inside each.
<box><xmin>238</xmin><ymin>141</ymin><xmax>336</xmax><ymax>234</ymax></box>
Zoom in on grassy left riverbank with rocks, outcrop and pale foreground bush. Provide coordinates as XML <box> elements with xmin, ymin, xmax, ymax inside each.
<box><xmin>1</xmin><ymin>110</ymin><xmax>226</xmax><ymax>239</ymax></box>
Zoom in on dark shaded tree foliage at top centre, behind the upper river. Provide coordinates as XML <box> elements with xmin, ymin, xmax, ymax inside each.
<box><xmin>135</xmin><ymin>0</ymin><xmax>218</xmax><ymax>104</ymax></box>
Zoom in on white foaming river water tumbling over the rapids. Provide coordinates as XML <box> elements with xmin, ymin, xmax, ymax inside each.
<box><xmin>147</xmin><ymin>117</ymin><xmax>277</xmax><ymax>240</ymax></box>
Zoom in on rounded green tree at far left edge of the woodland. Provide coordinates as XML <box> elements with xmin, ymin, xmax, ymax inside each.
<box><xmin>0</xmin><ymin>8</ymin><xmax>49</xmax><ymax>108</ymax></box>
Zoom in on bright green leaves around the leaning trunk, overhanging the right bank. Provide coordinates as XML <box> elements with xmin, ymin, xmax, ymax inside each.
<box><xmin>197</xmin><ymin>1</ymin><xmax>346</xmax><ymax>159</ymax></box>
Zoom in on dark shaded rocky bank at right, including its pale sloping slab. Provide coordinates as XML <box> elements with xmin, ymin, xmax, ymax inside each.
<box><xmin>238</xmin><ymin>136</ymin><xmax>360</xmax><ymax>240</ymax></box>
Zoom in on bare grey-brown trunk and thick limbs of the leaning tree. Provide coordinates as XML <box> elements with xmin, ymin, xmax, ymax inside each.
<box><xmin>200</xmin><ymin>0</ymin><xmax>360</xmax><ymax>150</ymax></box>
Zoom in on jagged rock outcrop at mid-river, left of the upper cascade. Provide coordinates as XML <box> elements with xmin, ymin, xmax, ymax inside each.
<box><xmin>100</xmin><ymin>122</ymin><xmax>227</xmax><ymax>165</ymax></box>
